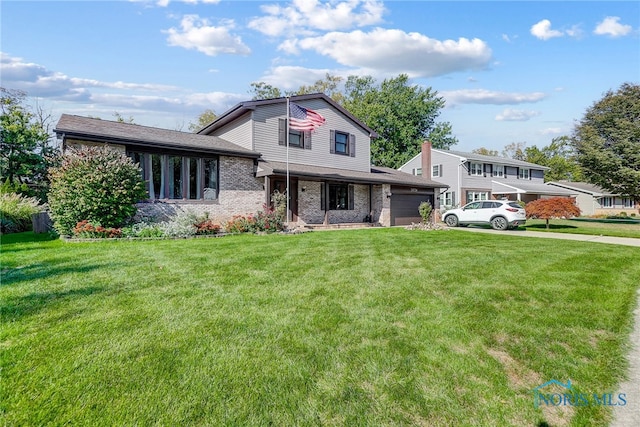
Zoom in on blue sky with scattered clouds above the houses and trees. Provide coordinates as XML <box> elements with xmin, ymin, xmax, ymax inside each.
<box><xmin>0</xmin><ymin>0</ymin><xmax>640</xmax><ymax>151</ymax></box>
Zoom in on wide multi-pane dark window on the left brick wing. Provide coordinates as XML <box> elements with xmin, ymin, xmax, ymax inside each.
<box><xmin>131</xmin><ymin>152</ymin><xmax>218</xmax><ymax>200</ymax></box>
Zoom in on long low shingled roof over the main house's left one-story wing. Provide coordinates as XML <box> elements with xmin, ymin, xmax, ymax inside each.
<box><xmin>54</xmin><ymin>114</ymin><xmax>260</xmax><ymax>158</ymax></box>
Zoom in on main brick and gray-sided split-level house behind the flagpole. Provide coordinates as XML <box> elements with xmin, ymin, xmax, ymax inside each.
<box><xmin>55</xmin><ymin>94</ymin><xmax>445</xmax><ymax>226</ymax></box>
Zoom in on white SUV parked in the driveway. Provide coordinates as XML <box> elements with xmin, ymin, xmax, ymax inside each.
<box><xmin>442</xmin><ymin>200</ymin><xmax>527</xmax><ymax>230</ymax></box>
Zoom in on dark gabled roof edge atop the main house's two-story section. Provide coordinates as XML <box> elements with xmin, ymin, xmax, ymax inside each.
<box><xmin>197</xmin><ymin>93</ymin><xmax>378</xmax><ymax>138</ymax></box>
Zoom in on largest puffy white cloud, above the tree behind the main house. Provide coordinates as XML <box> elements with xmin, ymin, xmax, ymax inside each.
<box><xmin>288</xmin><ymin>28</ymin><xmax>491</xmax><ymax>77</ymax></box>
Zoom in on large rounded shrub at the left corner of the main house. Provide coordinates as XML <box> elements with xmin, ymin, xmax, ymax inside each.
<box><xmin>49</xmin><ymin>146</ymin><xmax>146</xmax><ymax>235</ymax></box>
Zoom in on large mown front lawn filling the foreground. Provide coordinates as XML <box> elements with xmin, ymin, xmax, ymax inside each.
<box><xmin>0</xmin><ymin>232</ymin><xmax>640</xmax><ymax>426</ymax></box>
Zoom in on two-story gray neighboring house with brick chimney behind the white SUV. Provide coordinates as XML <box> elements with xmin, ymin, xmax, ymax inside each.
<box><xmin>399</xmin><ymin>142</ymin><xmax>575</xmax><ymax>207</ymax></box>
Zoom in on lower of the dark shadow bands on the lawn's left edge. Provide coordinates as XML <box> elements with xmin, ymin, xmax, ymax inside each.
<box><xmin>0</xmin><ymin>286</ymin><xmax>104</xmax><ymax>321</ymax></box>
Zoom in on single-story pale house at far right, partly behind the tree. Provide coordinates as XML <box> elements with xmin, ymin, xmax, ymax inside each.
<box><xmin>547</xmin><ymin>181</ymin><xmax>638</xmax><ymax>216</ymax></box>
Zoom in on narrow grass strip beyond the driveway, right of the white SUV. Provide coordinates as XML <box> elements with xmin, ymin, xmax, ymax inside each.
<box><xmin>521</xmin><ymin>219</ymin><xmax>640</xmax><ymax>239</ymax></box>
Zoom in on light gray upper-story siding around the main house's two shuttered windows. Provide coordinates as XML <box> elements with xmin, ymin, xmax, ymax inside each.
<box><xmin>250</xmin><ymin>99</ymin><xmax>371</xmax><ymax>172</ymax></box>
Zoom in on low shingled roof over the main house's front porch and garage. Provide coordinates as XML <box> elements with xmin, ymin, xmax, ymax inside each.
<box><xmin>256</xmin><ymin>161</ymin><xmax>448</xmax><ymax>188</ymax></box>
